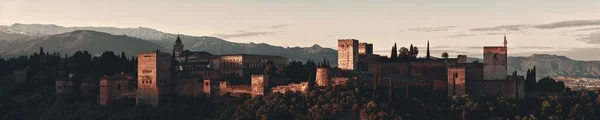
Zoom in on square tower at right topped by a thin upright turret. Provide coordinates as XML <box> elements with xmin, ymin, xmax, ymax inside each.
<box><xmin>483</xmin><ymin>37</ymin><xmax>508</xmax><ymax>80</ymax></box>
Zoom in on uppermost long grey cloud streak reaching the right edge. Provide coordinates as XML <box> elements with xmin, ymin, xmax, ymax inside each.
<box><xmin>531</xmin><ymin>20</ymin><xmax>600</xmax><ymax>29</ymax></box>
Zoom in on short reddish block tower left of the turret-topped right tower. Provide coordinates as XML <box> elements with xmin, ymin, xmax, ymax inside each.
<box><xmin>447</xmin><ymin>67</ymin><xmax>466</xmax><ymax>96</ymax></box>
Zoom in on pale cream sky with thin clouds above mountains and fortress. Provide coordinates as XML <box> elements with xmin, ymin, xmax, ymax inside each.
<box><xmin>0</xmin><ymin>0</ymin><xmax>600</xmax><ymax>60</ymax></box>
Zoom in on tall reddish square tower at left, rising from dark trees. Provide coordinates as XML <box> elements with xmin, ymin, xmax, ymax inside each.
<box><xmin>136</xmin><ymin>52</ymin><xmax>171</xmax><ymax>105</ymax></box>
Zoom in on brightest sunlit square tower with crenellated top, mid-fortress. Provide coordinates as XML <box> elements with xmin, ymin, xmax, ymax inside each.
<box><xmin>338</xmin><ymin>39</ymin><xmax>358</xmax><ymax>70</ymax></box>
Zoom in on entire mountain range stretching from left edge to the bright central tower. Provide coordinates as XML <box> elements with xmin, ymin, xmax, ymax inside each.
<box><xmin>0</xmin><ymin>23</ymin><xmax>337</xmax><ymax>63</ymax></box>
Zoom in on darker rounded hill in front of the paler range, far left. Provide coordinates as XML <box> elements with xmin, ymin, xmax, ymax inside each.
<box><xmin>2</xmin><ymin>30</ymin><xmax>161</xmax><ymax>56</ymax></box>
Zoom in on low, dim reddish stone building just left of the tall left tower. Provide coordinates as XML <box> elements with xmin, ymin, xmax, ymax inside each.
<box><xmin>99</xmin><ymin>73</ymin><xmax>137</xmax><ymax>105</ymax></box>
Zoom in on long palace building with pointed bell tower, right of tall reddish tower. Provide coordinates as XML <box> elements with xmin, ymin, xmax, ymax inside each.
<box><xmin>173</xmin><ymin>37</ymin><xmax>288</xmax><ymax>79</ymax></box>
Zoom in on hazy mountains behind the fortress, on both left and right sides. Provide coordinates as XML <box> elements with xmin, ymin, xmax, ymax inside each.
<box><xmin>0</xmin><ymin>24</ymin><xmax>600</xmax><ymax>78</ymax></box>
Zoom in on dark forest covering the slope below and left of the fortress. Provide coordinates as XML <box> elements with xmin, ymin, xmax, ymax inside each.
<box><xmin>0</xmin><ymin>49</ymin><xmax>600</xmax><ymax>120</ymax></box>
